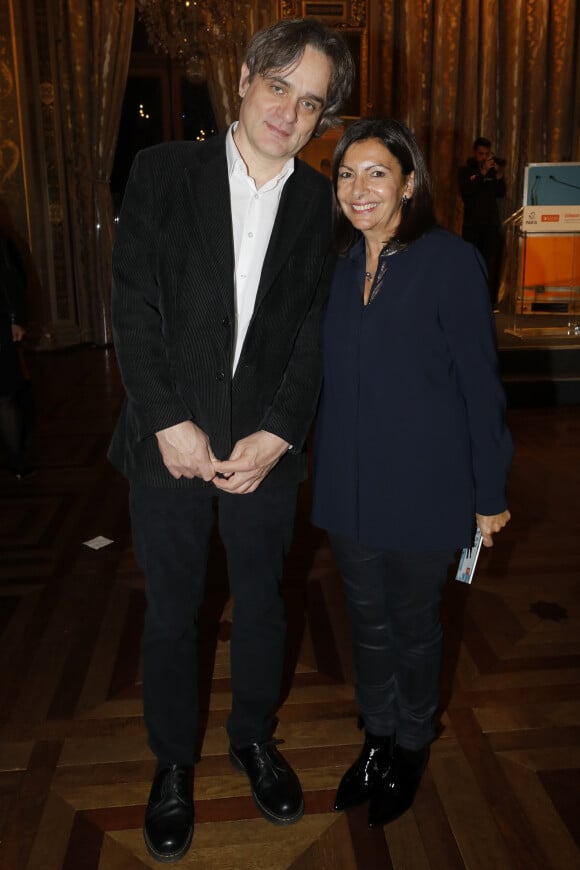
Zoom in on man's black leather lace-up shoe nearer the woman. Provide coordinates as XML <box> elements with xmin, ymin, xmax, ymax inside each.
<box><xmin>230</xmin><ymin>740</ymin><xmax>304</xmax><ymax>825</ymax></box>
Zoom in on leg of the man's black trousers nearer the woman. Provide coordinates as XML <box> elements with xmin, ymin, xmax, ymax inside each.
<box><xmin>219</xmin><ymin>484</ymin><xmax>298</xmax><ymax>748</ymax></box>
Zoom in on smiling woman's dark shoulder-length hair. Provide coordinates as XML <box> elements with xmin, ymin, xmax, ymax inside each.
<box><xmin>332</xmin><ymin>118</ymin><xmax>437</xmax><ymax>254</ymax></box>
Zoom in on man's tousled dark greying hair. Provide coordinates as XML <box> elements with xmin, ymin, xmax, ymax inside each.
<box><xmin>244</xmin><ymin>18</ymin><xmax>355</xmax><ymax>136</ymax></box>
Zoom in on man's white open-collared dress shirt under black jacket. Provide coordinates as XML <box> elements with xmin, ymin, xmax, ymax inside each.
<box><xmin>226</xmin><ymin>122</ymin><xmax>294</xmax><ymax>372</ymax></box>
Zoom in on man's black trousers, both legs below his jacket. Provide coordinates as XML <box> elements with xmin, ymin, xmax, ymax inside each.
<box><xmin>130</xmin><ymin>484</ymin><xmax>298</xmax><ymax>765</ymax></box>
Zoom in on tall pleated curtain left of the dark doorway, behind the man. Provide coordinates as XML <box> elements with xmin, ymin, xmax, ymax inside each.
<box><xmin>56</xmin><ymin>0</ymin><xmax>134</xmax><ymax>344</ymax></box>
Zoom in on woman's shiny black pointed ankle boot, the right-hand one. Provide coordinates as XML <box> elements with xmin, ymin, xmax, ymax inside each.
<box><xmin>369</xmin><ymin>744</ymin><xmax>429</xmax><ymax>828</ymax></box>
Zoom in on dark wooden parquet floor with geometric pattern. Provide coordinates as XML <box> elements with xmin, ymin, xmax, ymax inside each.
<box><xmin>0</xmin><ymin>348</ymin><xmax>580</xmax><ymax>870</ymax></box>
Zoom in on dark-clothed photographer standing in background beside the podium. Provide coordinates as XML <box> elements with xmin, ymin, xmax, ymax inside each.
<box><xmin>459</xmin><ymin>136</ymin><xmax>506</xmax><ymax>310</ymax></box>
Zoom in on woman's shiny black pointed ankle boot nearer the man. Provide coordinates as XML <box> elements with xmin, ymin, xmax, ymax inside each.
<box><xmin>334</xmin><ymin>732</ymin><xmax>394</xmax><ymax>811</ymax></box>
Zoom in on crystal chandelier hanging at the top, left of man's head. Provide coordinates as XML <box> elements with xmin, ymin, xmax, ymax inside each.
<box><xmin>136</xmin><ymin>0</ymin><xmax>252</xmax><ymax>79</ymax></box>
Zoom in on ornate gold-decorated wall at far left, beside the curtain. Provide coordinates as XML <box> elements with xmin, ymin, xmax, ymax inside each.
<box><xmin>0</xmin><ymin>0</ymin><xmax>79</xmax><ymax>346</ymax></box>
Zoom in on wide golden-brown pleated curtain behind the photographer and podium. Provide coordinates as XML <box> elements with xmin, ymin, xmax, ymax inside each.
<box><xmin>369</xmin><ymin>0</ymin><xmax>580</xmax><ymax>230</ymax></box>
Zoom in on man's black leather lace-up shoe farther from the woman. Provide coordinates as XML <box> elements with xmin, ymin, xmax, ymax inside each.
<box><xmin>143</xmin><ymin>764</ymin><xmax>193</xmax><ymax>864</ymax></box>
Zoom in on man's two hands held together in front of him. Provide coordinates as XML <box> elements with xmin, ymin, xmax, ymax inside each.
<box><xmin>156</xmin><ymin>420</ymin><xmax>289</xmax><ymax>494</ymax></box>
